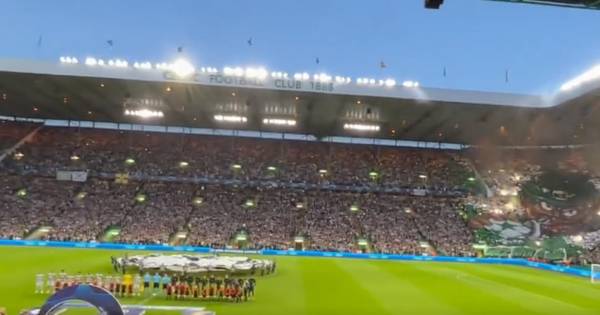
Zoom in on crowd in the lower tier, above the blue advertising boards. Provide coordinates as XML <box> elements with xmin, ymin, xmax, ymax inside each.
<box><xmin>0</xmin><ymin>176</ymin><xmax>471</xmax><ymax>255</ymax></box>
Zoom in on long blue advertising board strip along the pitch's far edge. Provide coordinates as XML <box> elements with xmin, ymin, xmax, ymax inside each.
<box><xmin>0</xmin><ymin>239</ymin><xmax>591</xmax><ymax>278</ymax></box>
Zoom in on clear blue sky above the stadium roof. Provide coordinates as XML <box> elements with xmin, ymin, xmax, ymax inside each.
<box><xmin>0</xmin><ymin>0</ymin><xmax>600</xmax><ymax>93</ymax></box>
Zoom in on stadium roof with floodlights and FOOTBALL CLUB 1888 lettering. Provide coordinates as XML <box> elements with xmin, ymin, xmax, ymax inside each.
<box><xmin>0</xmin><ymin>60</ymin><xmax>600</xmax><ymax>145</ymax></box>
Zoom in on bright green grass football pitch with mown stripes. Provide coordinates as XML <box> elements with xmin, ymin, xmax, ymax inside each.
<box><xmin>0</xmin><ymin>247</ymin><xmax>600</xmax><ymax>315</ymax></box>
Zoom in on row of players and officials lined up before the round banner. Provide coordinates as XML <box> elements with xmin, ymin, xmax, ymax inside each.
<box><xmin>35</xmin><ymin>272</ymin><xmax>256</xmax><ymax>302</ymax></box>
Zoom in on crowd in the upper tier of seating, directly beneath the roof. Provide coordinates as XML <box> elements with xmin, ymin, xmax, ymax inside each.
<box><xmin>3</xmin><ymin>127</ymin><xmax>469</xmax><ymax>190</ymax></box>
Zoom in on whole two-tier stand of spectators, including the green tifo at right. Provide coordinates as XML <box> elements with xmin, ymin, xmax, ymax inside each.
<box><xmin>0</xmin><ymin>122</ymin><xmax>600</xmax><ymax>261</ymax></box>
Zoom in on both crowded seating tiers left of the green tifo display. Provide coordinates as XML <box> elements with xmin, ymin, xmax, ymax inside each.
<box><xmin>2</xmin><ymin>126</ymin><xmax>472</xmax><ymax>255</ymax></box>
